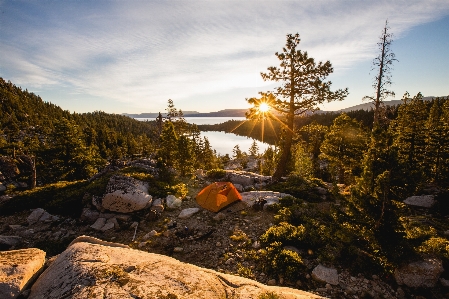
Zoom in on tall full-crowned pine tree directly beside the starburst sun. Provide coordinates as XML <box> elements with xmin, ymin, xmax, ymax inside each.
<box><xmin>248</xmin><ymin>33</ymin><xmax>348</xmax><ymax>179</ymax></box>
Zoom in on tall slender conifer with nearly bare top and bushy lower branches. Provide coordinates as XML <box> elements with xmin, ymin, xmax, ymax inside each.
<box><xmin>351</xmin><ymin>21</ymin><xmax>399</xmax><ymax>231</ymax></box>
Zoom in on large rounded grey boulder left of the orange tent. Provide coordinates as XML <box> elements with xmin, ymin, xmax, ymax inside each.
<box><xmin>102</xmin><ymin>175</ymin><xmax>152</xmax><ymax>213</ymax></box>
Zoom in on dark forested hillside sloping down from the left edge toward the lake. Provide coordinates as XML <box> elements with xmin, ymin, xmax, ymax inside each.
<box><xmin>0</xmin><ymin>78</ymin><xmax>222</xmax><ymax>185</ymax></box>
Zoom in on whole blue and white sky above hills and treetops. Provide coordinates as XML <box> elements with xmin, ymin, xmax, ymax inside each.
<box><xmin>0</xmin><ymin>0</ymin><xmax>449</xmax><ymax>113</ymax></box>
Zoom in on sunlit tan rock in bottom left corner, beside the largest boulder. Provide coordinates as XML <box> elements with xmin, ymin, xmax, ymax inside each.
<box><xmin>0</xmin><ymin>248</ymin><xmax>45</xmax><ymax>299</ymax></box>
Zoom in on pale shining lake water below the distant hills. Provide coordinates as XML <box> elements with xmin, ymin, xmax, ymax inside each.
<box><xmin>136</xmin><ymin>117</ymin><xmax>270</xmax><ymax>157</ymax></box>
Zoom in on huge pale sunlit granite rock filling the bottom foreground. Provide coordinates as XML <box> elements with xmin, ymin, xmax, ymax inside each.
<box><xmin>29</xmin><ymin>237</ymin><xmax>322</xmax><ymax>299</ymax></box>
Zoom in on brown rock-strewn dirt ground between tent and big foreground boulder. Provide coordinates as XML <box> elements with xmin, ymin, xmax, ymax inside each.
<box><xmin>0</xmin><ymin>162</ymin><xmax>449</xmax><ymax>298</ymax></box>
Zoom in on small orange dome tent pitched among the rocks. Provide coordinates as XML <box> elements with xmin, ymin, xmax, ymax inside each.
<box><xmin>196</xmin><ymin>182</ymin><xmax>242</xmax><ymax>212</ymax></box>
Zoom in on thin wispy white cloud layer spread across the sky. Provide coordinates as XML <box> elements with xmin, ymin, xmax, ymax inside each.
<box><xmin>0</xmin><ymin>0</ymin><xmax>449</xmax><ymax>112</ymax></box>
